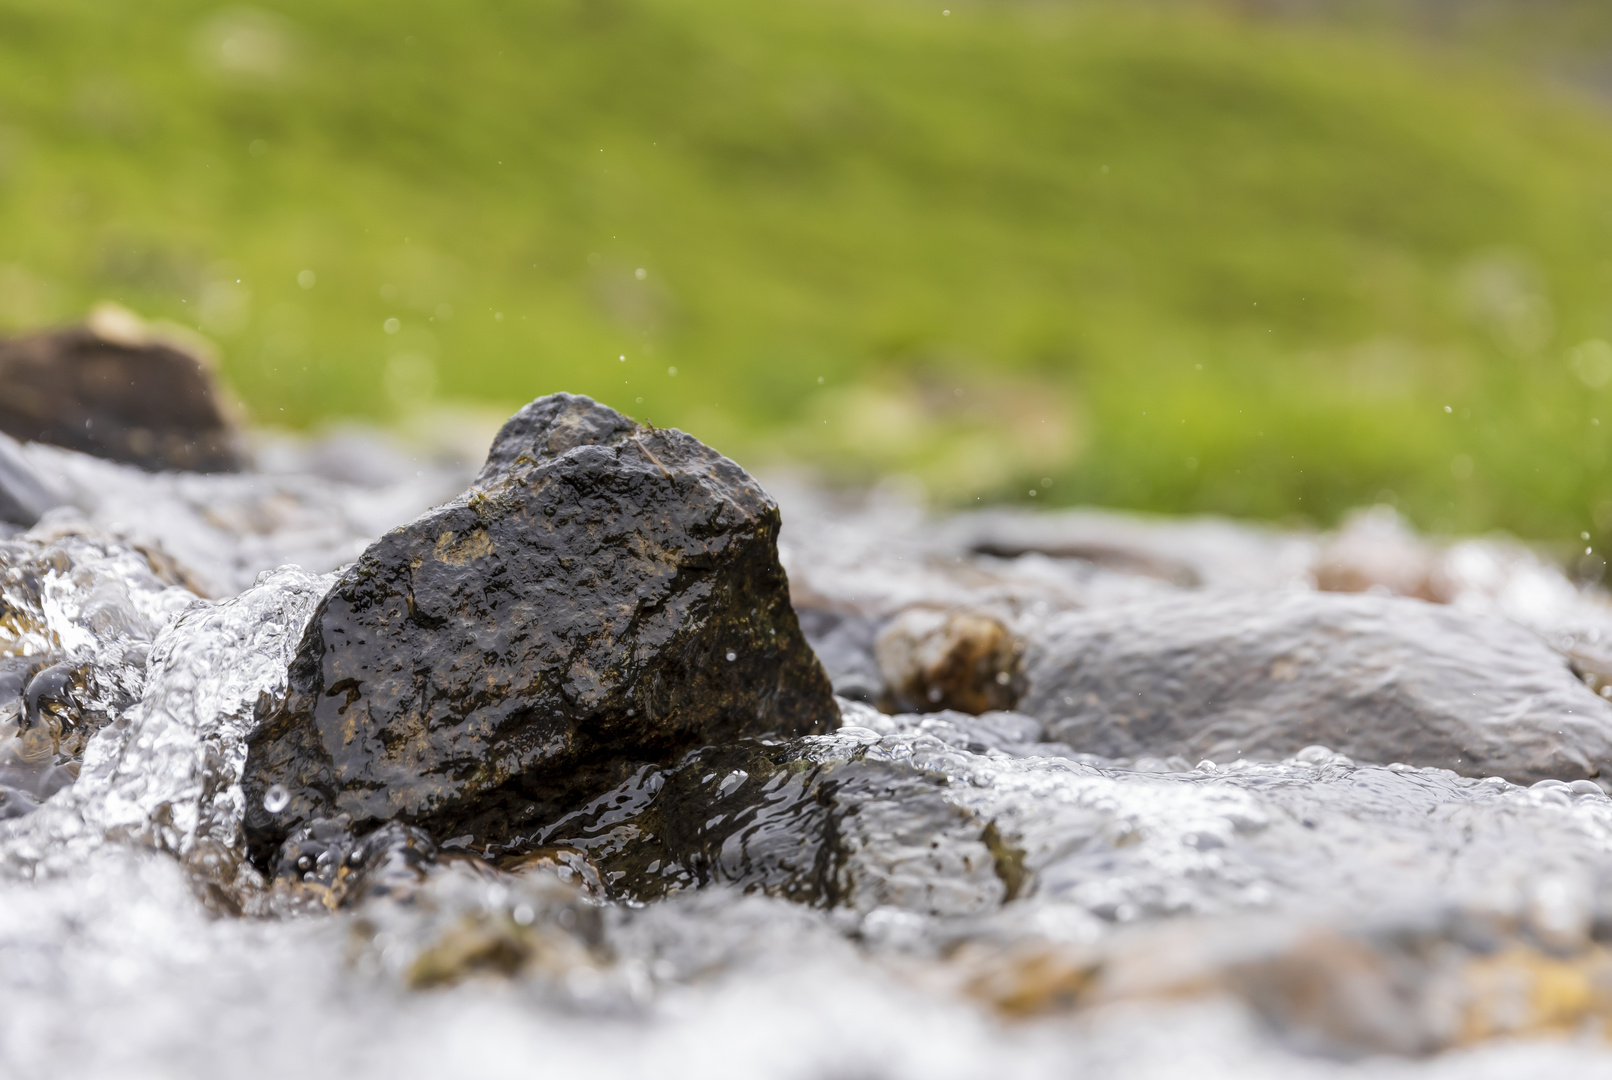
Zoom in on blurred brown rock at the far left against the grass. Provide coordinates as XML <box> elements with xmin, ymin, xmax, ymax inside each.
<box><xmin>0</xmin><ymin>314</ymin><xmax>242</xmax><ymax>472</ymax></box>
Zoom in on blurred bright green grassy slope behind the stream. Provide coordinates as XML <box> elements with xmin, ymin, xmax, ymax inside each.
<box><xmin>0</xmin><ymin>0</ymin><xmax>1612</xmax><ymax>538</ymax></box>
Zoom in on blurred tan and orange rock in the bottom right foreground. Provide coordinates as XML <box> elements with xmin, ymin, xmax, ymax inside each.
<box><xmin>949</xmin><ymin>919</ymin><xmax>1612</xmax><ymax>1056</ymax></box>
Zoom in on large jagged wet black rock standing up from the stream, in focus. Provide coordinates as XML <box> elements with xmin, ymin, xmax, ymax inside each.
<box><xmin>245</xmin><ymin>395</ymin><xmax>838</xmax><ymax>866</ymax></box>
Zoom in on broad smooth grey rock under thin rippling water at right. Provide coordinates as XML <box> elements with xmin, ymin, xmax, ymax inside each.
<box><xmin>1019</xmin><ymin>592</ymin><xmax>1612</xmax><ymax>783</ymax></box>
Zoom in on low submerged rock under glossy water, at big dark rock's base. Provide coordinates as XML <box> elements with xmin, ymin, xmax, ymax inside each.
<box><xmin>506</xmin><ymin>732</ymin><xmax>1022</xmax><ymax>916</ymax></box>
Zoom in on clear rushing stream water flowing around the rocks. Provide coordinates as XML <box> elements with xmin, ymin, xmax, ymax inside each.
<box><xmin>9</xmin><ymin>447</ymin><xmax>1612</xmax><ymax>1078</ymax></box>
